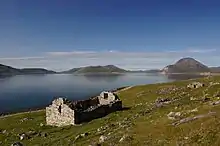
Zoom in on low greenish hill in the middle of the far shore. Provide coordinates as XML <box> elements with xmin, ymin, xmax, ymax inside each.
<box><xmin>62</xmin><ymin>65</ymin><xmax>127</xmax><ymax>74</ymax></box>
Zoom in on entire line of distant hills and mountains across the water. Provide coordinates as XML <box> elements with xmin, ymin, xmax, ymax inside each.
<box><xmin>0</xmin><ymin>58</ymin><xmax>220</xmax><ymax>76</ymax></box>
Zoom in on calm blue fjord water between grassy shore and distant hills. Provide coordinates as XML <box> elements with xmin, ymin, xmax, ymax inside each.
<box><xmin>0</xmin><ymin>73</ymin><xmax>175</xmax><ymax>114</ymax></box>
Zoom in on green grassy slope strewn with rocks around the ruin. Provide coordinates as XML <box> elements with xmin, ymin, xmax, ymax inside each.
<box><xmin>0</xmin><ymin>77</ymin><xmax>220</xmax><ymax>146</ymax></box>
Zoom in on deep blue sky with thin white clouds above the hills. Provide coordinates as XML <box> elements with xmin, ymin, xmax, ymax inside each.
<box><xmin>0</xmin><ymin>0</ymin><xmax>220</xmax><ymax>70</ymax></box>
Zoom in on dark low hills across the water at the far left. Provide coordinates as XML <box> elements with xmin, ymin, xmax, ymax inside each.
<box><xmin>0</xmin><ymin>64</ymin><xmax>56</xmax><ymax>76</ymax></box>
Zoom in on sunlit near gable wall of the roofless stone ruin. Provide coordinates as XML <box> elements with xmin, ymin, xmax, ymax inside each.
<box><xmin>46</xmin><ymin>99</ymin><xmax>75</xmax><ymax>126</ymax></box>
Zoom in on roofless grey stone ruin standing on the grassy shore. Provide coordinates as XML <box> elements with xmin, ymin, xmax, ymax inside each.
<box><xmin>46</xmin><ymin>91</ymin><xmax>122</xmax><ymax>127</ymax></box>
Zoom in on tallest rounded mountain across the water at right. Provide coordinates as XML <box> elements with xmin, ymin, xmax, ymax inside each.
<box><xmin>162</xmin><ymin>58</ymin><xmax>210</xmax><ymax>74</ymax></box>
